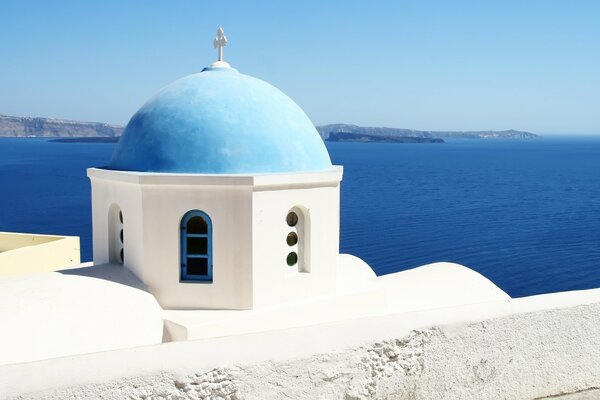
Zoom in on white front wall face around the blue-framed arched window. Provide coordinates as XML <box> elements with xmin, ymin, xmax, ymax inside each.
<box><xmin>141</xmin><ymin>181</ymin><xmax>252</xmax><ymax>309</ymax></box>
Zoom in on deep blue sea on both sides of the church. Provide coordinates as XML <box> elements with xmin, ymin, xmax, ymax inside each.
<box><xmin>0</xmin><ymin>137</ymin><xmax>600</xmax><ymax>297</ymax></box>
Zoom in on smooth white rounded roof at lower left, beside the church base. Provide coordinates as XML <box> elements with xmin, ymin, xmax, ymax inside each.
<box><xmin>0</xmin><ymin>266</ymin><xmax>163</xmax><ymax>368</ymax></box>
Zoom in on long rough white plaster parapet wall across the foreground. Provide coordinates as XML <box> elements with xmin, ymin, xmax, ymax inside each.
<box><xmin>0</xmin><ymin>289</ymin><xmax>600</xmax><ymax>400</ymax></box>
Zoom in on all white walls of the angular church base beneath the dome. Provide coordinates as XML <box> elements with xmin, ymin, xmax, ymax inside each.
<box><xmin>88</xmin><ymin>167</ymin><xmax>342</xmax><ymax>309</ymax></box>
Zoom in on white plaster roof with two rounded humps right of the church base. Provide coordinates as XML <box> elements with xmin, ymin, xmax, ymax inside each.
<box><xmin>165</xmin><ymin>260</ymin><xmax>510</xmax><ymax>340</ymax></box>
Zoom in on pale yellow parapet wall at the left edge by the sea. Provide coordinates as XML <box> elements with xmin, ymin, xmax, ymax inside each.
<box><xmin>0</xmin><ymin>232</ymin><xmax>81</xmax><ymax>277</ymax></box>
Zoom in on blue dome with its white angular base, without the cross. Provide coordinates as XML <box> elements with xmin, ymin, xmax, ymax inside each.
<box><xmin>88</xmin><ymin>39</ymin><xmax>342</xmax><ymax>310</ymax></box>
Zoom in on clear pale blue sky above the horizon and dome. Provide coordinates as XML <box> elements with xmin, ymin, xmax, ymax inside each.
<box><xmin>0</xmin><ymin>0</ymin><xmax>600</xmax><ymax>134</ymax></box>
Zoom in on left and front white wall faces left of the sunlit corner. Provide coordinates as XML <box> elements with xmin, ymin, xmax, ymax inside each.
<box><xmin>88</xmin><ymin>168</ymin><xmax>252</xmax><ymax>309</ymax></box>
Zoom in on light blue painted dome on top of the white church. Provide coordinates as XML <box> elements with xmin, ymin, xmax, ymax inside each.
<box><xmin>108</xmin><ymin>67</ymin><xmax>331</xmax><ymax>174</ymax></box>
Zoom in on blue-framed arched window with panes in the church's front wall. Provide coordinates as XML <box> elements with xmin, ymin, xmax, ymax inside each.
<box><xmin>180</xmin><ymin>210</ymin><xmax>212</xmax><ymax>282</ymax></box>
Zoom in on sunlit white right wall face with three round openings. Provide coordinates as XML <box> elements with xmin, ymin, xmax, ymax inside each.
<box><xmin>253</xmin><ymin>170</ymin><xmax>342</xmax><ymax>308</ymax></box>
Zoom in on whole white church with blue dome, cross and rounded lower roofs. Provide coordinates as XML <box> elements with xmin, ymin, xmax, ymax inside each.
<box><xmin>0</xmin><ymin>29</ymin><xmax>598</xmax><ymax>397</ymax></box>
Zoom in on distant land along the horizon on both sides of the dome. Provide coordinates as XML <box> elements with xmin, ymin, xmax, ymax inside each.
<box><xmin>0</xmin><ymin>114</ymin><xmax>538</xmax><ymax>143</ymax></box>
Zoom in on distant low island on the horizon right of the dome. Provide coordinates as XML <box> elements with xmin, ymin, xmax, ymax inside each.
<box><xmin>317</xmin><ymin>124</ymin><xmax>538</xmax><ymax>143</ymax></box>
